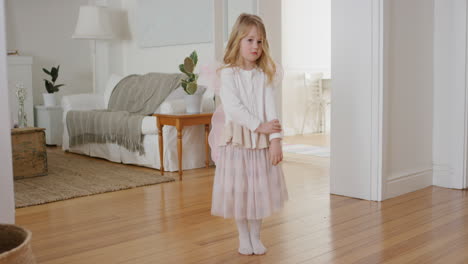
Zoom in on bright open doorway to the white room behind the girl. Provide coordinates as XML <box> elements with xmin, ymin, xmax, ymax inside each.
<box><xmin>281</xmin><ymin>0</ymin><xmax>331</xmax><ymax>163</ymax></box>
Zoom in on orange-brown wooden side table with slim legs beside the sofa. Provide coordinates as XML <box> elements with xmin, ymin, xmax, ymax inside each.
<box><xmin>153</xmin><ymin>112</ymin><xmax>213</xmax><ymax>180</ymax></box>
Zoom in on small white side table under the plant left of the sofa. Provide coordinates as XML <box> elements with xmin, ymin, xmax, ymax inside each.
<box><xmin>34</xmin><ymin>105</ymin><xmax>63</xmax><ymax>145</ymax></box>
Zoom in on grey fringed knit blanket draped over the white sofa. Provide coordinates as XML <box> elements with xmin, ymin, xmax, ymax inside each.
<box><xmin>66</xmin><ymin>73</ymin><xmax>182</xmax><ymax>155</ymax></box>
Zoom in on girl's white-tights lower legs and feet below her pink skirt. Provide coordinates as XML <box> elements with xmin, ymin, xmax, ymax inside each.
<box><xmin>236</xmin><ymin>219</ymin><xmax>266</xmax><ymax>255</ymax></box>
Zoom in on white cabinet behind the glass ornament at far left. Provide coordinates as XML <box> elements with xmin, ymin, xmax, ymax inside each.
<box><xmin>7</xmin><ymin>55</ymin><xmax>34</xmax><ymax>127</ymax></box>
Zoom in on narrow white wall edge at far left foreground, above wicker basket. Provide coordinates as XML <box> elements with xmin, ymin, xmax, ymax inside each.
<box><xmin>0</xmin><ymin>0</ymin><xmax>15</xmax><ymax>224</ymax></box>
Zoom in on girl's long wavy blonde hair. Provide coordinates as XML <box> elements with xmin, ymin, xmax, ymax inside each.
<box><xmin>221</xmin><ymin>13</ymin><xmax>276</xmax><ymax>83</ymax></box>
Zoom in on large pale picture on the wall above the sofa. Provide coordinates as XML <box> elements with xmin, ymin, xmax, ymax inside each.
<box><xmin>135</xmin><ymin>0</ymin><xmax>214</xmax><ymax>48</ymax></box>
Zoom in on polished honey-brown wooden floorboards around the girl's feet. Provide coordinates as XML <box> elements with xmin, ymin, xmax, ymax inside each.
<box><xmin>16</xmin><ymin>137</ymin><xmax>468</xmax><ymax>264</ymax></box>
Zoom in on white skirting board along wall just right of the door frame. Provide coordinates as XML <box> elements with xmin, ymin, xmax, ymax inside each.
<box><xmin>385</xmin><ymin>169</ymin><xmax>432</xmax><ymax>199</ymax></box>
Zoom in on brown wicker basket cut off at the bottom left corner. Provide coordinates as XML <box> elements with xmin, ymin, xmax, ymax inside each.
<box><xmin>0</xmin><ymin>224</ymin><xmax>36</xmax><ymax>264</ymax></box>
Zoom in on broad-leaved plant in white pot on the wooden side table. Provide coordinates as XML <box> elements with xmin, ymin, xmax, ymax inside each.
<box><xmin>179</xmin><ymin>50</ymin><xmax>206</xmax><ymax>113</ymax></box>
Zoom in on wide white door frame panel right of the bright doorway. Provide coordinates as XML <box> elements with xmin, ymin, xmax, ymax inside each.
<box><xmin>330</xmin><ymin>0</ymin><xmax>385</xmax><ymax>201</ymax></box>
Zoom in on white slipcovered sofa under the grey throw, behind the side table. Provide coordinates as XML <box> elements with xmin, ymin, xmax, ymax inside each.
<box><xmin>62</xmin><ymin>75</ymin><xmax>214</xmax><ymax>171</ymax></box>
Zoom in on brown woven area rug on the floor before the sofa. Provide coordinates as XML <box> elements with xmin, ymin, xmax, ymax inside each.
<box><xmin>15</xmin><ymin>150</ymin><xmax>174</xmax><ymax>208</ymax></box>
